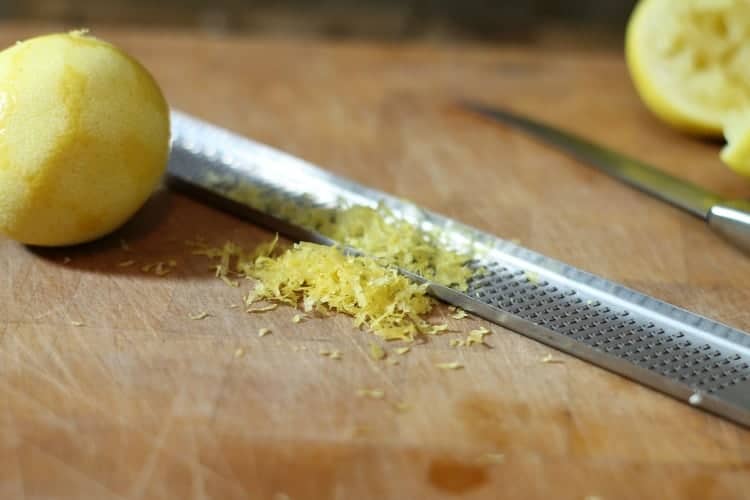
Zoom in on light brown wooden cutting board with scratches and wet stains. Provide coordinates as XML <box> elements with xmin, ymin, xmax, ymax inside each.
<box><xmin>0</xmin><ymin>26</ymin><xmax>750</xmax><ymax>500</ymax></box>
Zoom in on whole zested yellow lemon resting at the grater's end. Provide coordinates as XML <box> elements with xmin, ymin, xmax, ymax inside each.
<box><xmin>0</xmin><ymin>32</ymin><xmax>169</xmax><ymax>246</ymax></box>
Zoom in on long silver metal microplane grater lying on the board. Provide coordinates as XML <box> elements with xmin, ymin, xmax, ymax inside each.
<box><xmin>168</xmin><ymin>111</ymin><xmax>750</xmax><ymax>426</ymax></box>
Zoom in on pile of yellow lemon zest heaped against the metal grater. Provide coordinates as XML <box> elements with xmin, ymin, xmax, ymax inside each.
<box><xmin>187</xmin><ymin>197</ymin><xmax>472</xmax><ymax>341</ymax></box>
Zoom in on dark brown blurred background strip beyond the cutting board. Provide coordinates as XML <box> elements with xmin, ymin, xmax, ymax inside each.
<box><xmin>0</xmin><ymin>0</ymin><xmax>635</xmax><ymax>49</ymax></box>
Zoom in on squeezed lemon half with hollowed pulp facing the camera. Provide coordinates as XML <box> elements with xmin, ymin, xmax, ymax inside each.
<box><xmin>625</xmin><ymin>0</ymin><xmax>750</xmax><ymax>136</ymax></box>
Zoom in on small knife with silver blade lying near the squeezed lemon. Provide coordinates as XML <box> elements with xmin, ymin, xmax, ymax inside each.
<box><xmin>462</xmin><ymin>101</ymin><xmax>750</xmax><ymax>253</ymax></box>
